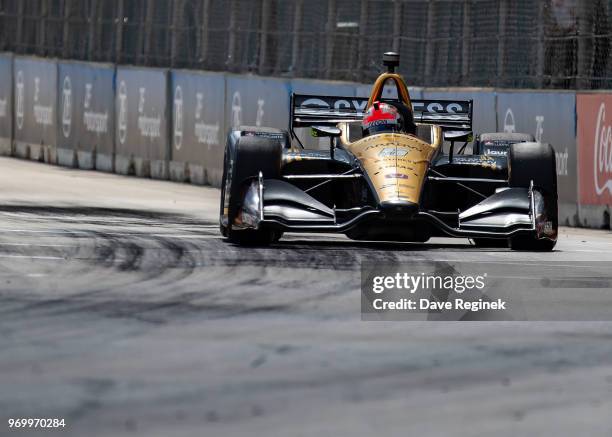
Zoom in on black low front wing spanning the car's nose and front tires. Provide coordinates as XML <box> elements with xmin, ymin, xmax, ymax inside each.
<box><xmin>233</xmin><ymin>175</ymin><xmax>554</xmax><ymax>239</ymax></box>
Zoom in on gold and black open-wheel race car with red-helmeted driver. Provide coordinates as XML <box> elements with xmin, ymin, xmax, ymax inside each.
<box><xmin>220</xmin><ymin>53</ymin><xmax>558</xmax><ymax>251</ymax></box>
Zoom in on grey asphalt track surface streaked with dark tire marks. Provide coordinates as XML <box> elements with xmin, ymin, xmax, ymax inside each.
<box><xmin>0</xmin><ymin>159</ymin><xmax>612</xmax><ymax>437</ymax></box>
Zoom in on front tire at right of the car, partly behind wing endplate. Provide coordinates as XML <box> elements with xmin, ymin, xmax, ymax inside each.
<box><xmin>508</xmin><ymin>142</ymin><xmax>559</xmax><ymax>251</ymax></box>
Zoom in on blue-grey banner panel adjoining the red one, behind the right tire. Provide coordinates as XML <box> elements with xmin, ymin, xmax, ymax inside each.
<box><xmin>497</xmin><ymin>92</ymin><xmax>578</xmax><ymax>209</ymax></box>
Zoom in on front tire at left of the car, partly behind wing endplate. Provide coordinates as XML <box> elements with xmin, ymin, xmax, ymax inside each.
<box><xmin>220</xmin><ymin>132</ymin><xmax>283</xmax><ymax>245</ymax></box>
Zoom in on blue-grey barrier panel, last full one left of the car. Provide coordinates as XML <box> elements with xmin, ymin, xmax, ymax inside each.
<box><xmin>170</xmin><ymin>71</ymin><xmax>225</xmax><ymax>185</ymax></box>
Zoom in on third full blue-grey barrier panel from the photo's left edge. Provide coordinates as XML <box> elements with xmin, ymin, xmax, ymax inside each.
<box><xmin>115</xmin><ymin>67</ymin><xmax>170</xmax><ymax>179</ymax></box>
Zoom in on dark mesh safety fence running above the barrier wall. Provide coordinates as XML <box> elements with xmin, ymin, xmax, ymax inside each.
<box><xmin>0</xmin><ymin>0</ymin><xmax>612</xmax><ymax>89</ymax></box>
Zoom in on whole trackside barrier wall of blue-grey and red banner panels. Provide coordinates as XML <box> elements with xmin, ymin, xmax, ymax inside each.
<box><xmin>0</xmin><ymin>54</ymin><xmax>612</xmax><ymax>228</ymax></box>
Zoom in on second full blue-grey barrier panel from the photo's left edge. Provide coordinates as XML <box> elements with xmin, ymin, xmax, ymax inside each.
<box><xmin>57</xmin><ymin>62</ymin><xmax>115</xmax><ymax>171</ymax></box>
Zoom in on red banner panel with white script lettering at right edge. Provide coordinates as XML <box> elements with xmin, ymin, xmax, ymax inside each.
<box><xmin>576</xmin><ymin>94</ymin><xmax>612</xmax><ymax>205</ymax></box>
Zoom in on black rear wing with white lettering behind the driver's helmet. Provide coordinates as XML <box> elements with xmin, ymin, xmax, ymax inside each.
<box><xmin>290</xmin><ymin>94</ymin><xmax>474</xmax><ymax>137</ymax></box>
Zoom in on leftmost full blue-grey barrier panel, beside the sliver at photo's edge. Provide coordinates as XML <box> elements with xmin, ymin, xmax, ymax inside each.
<box><xmin>13</xmin><ymin>56</ymin><xmax>57</xmax><ymax>164</ymax></box>
